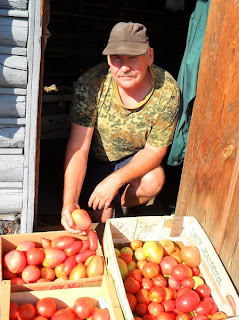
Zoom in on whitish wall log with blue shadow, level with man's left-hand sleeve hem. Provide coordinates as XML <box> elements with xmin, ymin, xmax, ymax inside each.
<box><xmin>0</xmin><ymin>125</ymin><xmax>25</xmax><ymax>148</ymax></box>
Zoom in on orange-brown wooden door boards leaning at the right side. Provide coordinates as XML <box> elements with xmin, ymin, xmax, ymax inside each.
<box><xmin>176</xmin><ymin>0</ymin><xmax>239</xmax><ymax>289</ymax></box>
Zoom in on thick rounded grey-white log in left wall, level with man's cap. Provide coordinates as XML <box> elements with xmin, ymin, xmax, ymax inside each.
<box><xmin>0</xmin><ymin>17</ymin><xmax>28</xmax><ymax>48</ymax></box>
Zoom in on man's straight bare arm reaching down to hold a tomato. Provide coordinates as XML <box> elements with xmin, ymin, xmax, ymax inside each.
<box><xmin>61</xmin><ymin>123</ymin><xmax>94</xmax><ymax>233</ymax></box>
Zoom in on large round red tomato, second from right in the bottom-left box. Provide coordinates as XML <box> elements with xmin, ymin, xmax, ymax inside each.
<box><xmin>74</xmin><ymin>297</ymin><xmax>98</xmax><ymax>319</ymax></box>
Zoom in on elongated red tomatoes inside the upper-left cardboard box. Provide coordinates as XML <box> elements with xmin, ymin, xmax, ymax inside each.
<box><xmin>3</xmin><ymin>230</ymin><xmax>104</xmax><ymax>284</ymax></box>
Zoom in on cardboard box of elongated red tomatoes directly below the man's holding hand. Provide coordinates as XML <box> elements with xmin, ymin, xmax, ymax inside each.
<box><xmin>0</xmin><ymin>209</ymin><xmax>105</xmax><ymax>291</ymax></box>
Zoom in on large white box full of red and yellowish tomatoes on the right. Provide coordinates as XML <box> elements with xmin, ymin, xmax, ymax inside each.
<box><xmin>103</xmin><ymin>216</ymin><xmax>239</xmax><ymax>320</ymax></box>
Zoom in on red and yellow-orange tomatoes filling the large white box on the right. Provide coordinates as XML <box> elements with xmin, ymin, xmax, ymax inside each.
<box><xmin>115</xmin><ymin>239</ymin><xmax>227</xmax><ymax>320</ymax></box>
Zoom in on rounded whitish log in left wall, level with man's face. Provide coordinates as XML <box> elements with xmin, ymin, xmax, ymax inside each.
<box><xmin>0</xmin><ymin>54</ymin><xmax>27</xmax><ymax>88</ymax></box>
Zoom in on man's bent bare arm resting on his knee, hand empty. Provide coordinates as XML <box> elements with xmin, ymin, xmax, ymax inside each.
<box><xmin>89</xmin><ymin>143</ymin><xmax>168</xmax><ymax>210</ymax></box>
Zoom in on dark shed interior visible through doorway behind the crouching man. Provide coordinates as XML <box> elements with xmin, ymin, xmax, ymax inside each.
<box><xmin>35</xmin><ymin>0</ymin><xmax>195</xmax><ymax>231</ymax></box>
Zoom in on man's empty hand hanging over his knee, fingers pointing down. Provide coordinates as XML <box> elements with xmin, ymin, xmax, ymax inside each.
<box><xmin>88</xmin><ymin>172</ymin><xmax>121</xmax><ymax>210</ymax></box>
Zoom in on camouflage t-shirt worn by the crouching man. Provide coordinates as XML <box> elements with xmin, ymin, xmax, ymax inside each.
<box><xmin>71</xmin><ymin>63</ymin><xmax>180</xmax><ymax>162</ymax></box>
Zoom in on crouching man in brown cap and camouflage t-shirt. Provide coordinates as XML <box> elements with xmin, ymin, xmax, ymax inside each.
<box><xmin>62</xmin><ymin>22</ymin><xmax>180</xmax><ymax>232</ymax></box>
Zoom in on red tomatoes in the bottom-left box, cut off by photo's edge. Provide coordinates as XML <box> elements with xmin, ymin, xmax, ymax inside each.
<box><xmin>9</xmin><ymin>297</ymin><xmax>110</xmax><ymax>320</ymax></box>
